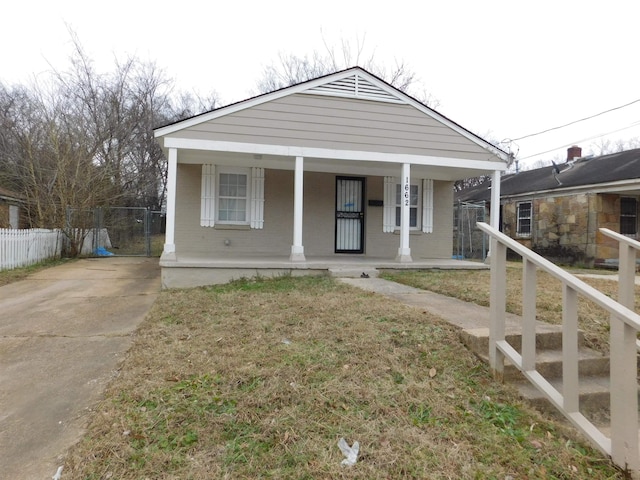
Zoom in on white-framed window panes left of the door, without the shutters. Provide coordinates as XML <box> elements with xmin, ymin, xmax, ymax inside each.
<box><xmin>217</xmin><ymin>170</ymin><xmax>249</xmax><ymax>224</ymax></box>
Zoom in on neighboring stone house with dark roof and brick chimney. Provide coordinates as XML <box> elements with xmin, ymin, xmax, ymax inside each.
<box><xmin>456</xmin><ymin>146</ymin><xmax>640</xmax><ymax>266</ymax></box>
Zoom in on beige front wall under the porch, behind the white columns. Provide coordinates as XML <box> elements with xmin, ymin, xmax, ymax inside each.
<box><xmin>175</xmin><ymin>164</ymin><xmax>453</xmax><ymax>259</ymax></box>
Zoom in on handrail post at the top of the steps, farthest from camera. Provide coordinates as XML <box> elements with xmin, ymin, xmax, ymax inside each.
<box><xmin>489</xmin><ymin>237</ymin><xmax>507</xmax><ymax>380</ymax></box>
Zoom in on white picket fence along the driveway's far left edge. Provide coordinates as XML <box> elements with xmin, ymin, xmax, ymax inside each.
<box><xmin>0</xmin><ymin>228</ymin><xmax>64</xmax><ymax>271</ymax></box>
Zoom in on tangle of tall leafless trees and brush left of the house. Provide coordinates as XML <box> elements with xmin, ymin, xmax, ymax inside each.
<box><xmin>0</xmin><ymin>32</ymin><xmax>217</xmax><ymax>250</ymax></box>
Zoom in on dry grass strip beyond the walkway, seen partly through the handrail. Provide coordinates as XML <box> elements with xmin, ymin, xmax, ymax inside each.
<box><xmin>383</xmin><ymin>262</ymin><xmax>640</xmax><ymax>353</ymax></box>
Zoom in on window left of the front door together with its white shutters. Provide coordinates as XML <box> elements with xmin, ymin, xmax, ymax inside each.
<box><xmin>200</xmin><ymin>165</ymin><xmax>264</xmax><ymax>229</ymax></box>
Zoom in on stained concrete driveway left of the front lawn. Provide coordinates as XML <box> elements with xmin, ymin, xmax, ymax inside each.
<box><xmin>0</xmin><ymin>257</ymin><xmax>160</xmax><ymax>480</ymax></box>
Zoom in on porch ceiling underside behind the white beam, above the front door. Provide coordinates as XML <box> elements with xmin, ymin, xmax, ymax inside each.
<box><xmin>178</xmin><ymin>149</ymin><xmax>501</xmax><ymax>181</ymax></box>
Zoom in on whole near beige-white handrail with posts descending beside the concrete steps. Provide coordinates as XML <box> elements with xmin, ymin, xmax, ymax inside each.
<box><xmin>478</xmin><ymin>222</ymin><xmax>640</xmax><ymax>472</ymax></box>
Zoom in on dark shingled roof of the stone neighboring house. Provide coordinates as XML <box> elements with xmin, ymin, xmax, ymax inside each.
<box><xmin>456</xmin><ymin>148</ymin><xmax>640</xmax><ymax>201</ymax></box>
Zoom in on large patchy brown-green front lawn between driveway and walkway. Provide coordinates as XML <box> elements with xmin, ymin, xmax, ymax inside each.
<box><xmin>64</xmin><ymin>277</ymin><xmax>624</xmax><ymax>480</ymax></box>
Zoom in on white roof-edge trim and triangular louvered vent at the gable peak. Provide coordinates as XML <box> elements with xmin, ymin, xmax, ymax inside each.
<box><xmin>154</xmin><ymin>66</ymin><xmax>508</xmax><ymax>161</ymax></box>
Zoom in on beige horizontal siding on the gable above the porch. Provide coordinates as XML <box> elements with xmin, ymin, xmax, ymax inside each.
<box><xmin>168</xmin><ymin>94</ymin><xmax>495</xmax><ymax>160</ymax></box>
